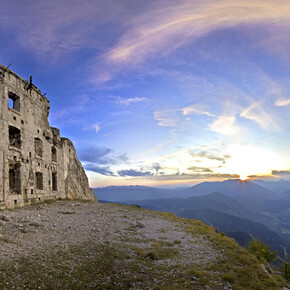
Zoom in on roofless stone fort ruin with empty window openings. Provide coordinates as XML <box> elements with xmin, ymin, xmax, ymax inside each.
<box><xmin>0</xmin><ymin>65</ymin><xmax>95</xmax><ymax>208</ymax></box>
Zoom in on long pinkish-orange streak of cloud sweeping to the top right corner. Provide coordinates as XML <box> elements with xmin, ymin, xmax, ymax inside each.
<box><xmin>106</xmin><ymin>0</ymin><xmax>290</xmax><ymax>68</ymax></box>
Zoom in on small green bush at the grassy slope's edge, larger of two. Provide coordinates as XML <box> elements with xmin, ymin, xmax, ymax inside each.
<box><xmin>248</xmin><ymin>239</ymin><xmax>277</xmax><ymax>263</ymax></box>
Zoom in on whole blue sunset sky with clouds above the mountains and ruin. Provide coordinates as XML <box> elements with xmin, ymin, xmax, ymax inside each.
<box><xmin>0</xmin><ymin>0</ymin><xmax>290</xmax><ymax>187</ymax></box>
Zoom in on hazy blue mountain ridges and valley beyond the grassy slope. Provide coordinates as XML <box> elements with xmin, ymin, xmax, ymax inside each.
<box><xmin>95</xmin><ymin>179</ymin><xmax>290</xmax><ymax>260</ymax></box>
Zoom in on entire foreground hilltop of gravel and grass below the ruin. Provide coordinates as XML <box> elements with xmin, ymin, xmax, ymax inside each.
<box><xmin>0</xmin><ymin>201</ymin><xmax>286</xmax><ymax>289</ymax></box>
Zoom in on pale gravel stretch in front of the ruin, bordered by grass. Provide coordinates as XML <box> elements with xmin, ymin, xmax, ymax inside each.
<box><xmin>0</xmin><ymin>201</ymin><xmax>219</xmax><ymax>264</ymax></box>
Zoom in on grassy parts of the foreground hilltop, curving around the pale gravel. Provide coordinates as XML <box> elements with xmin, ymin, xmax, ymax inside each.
<box><xmin>0</xmin><ymin>205</ymin><xmax>286</xmax><ymax>290</ymax></box>
